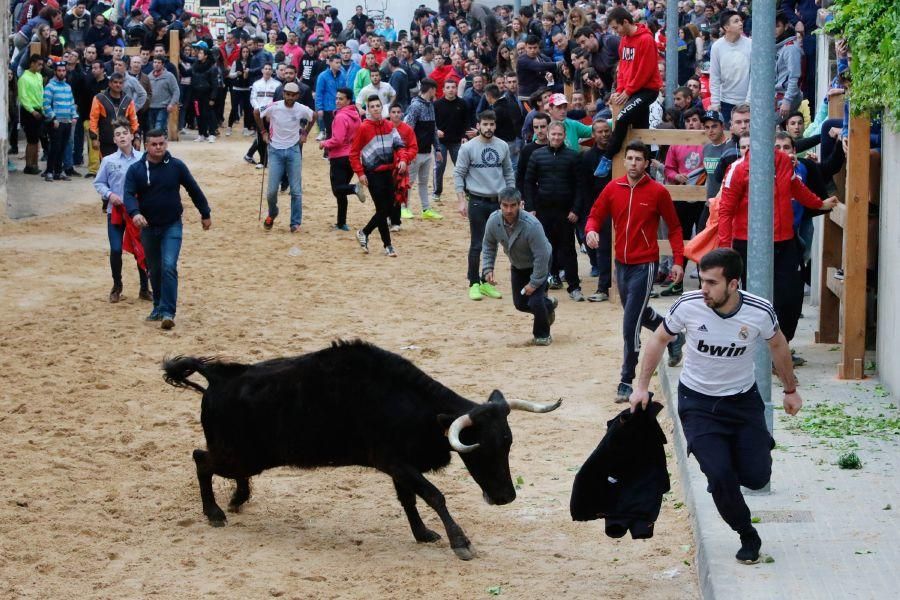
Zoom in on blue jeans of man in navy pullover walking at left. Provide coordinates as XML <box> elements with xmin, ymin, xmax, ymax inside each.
<box><xmin>141</xmin><ymin>220</ymin><xmax>182</xmax><ymax>317</ymax></box>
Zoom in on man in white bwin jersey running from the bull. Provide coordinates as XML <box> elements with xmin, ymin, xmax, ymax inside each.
<box><xmin>630</xmin><ymin>248</ymin><xmax>803</xmax><ymax>564</ymax></box>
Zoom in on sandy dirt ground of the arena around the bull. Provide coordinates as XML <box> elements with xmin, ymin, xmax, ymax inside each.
<box><xmin>0</xmin><ymin>136</ymin><xmax>698</xmax><ymax>599</ymax></box>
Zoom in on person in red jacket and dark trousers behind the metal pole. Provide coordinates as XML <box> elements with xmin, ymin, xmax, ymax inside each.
<box><xmin>719</xmin><ymin>145</ymin><xmax>837</xmax><ymax>342</ymax></box>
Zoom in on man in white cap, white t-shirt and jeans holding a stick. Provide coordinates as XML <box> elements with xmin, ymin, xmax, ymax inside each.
<box><xmin>253</xmin><ymin>81</ymin><xmax>315</xmax><ymax>233</ymax></box>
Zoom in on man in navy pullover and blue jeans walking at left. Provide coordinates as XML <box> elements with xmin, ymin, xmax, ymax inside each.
<box><xmin>125</xmin><ymin>129</ymin><xmax>212</xmax><ymax>329</ymax></box>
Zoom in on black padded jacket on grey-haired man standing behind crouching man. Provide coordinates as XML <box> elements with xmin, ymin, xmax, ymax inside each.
<box><xmin>524</xmin><ymin>144</ymin><xmax>582</xmax><ymax>214</ymax></box>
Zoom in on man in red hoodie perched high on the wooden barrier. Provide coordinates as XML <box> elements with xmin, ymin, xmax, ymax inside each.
<box><xmin>594</xmin><ymin>6</ymin><xmax>663</xmax><ymax>177</ymax></box>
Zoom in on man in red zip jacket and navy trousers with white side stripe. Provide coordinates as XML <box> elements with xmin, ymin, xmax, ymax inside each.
<box><xmin>584</xmin><ymin>142</ymin><xmax>684</xmax><ymax>403</ymax></box>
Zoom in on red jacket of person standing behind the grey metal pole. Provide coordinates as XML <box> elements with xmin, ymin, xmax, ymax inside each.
<box><xmin>719</xmin><ymin>150</ymin><xmax>822</xmax><ymax>248</ymax></box>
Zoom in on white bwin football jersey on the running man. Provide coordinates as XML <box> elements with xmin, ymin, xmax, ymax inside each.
<box><xmin>663</xmin><ymin>290</ymin><xmax>778</xmax><ymax>396</ymax></box>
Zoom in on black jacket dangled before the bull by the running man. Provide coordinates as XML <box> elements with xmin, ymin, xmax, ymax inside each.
<box><xmin>569</xmin><ymin>402</ymin><xmax>669</xmax><ymax>539</ymax></box>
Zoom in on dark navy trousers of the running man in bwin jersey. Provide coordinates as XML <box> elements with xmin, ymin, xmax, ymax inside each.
<box><xmin>678</xmin><ymin>383</ymin><xmax>775</xmax><ymax>532</ymax></box>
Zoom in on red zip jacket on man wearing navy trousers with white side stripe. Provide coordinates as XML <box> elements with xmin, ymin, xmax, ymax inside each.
<box><xmin>584</xmin><ymin>173</ymin><xmax>684</xmax><ymax>265</ymax></box>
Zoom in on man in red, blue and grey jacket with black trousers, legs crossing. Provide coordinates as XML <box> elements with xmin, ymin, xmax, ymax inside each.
<box><xmin>350</xmin><ymin>94</ymin><xmax>409</xmax><ymax>257</ymax></box>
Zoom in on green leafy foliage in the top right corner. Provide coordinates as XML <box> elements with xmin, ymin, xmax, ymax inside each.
<box><xmin>825</xmin><ymin>0</ymin><xmax>900</xmax><ymax>127</ymax></box>
